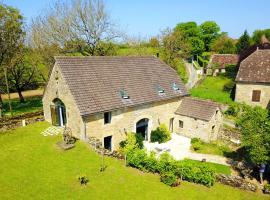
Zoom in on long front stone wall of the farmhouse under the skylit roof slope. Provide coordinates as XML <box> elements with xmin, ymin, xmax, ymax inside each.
<box><xmin>86</xmin><ymin>98</ymin><xmax>181</xmax><ymax>150</ymax></box>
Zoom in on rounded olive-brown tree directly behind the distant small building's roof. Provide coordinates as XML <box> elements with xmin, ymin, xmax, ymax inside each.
<box><xmin>211</xmin><ymin>35</ymin><xmax>236</xmax><ymax>54</ymax></box>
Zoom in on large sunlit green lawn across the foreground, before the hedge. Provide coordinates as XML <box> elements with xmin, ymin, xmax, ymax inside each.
<box><xmin>0</xmin><ymin>122</ymin><xmax>269</xmax><ymax>200</ymax></box>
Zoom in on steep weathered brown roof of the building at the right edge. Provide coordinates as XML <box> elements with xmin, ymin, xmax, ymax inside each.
<box><xmin>236</xmin><ymin>50</ymin><xmax>270</xmax><ymax>83</ymax></box>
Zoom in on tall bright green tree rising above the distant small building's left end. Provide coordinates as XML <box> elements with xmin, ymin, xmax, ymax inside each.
<box><xmin>200</xmin><ymin>21</ymin><xmax>220</xmax><ymax>51</ymax></box>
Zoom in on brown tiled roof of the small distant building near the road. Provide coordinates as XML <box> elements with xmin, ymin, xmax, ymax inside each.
<box><xmin>209</xmin><ymin>54</ymin><xmax>239</xmax><ymax>69</ymax></box>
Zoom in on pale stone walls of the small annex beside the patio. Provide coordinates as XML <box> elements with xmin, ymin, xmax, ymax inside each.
<box><xmin>175</xmin><ymin>109</ymin><xmax>222</xmax><ymax>142</ymax></box>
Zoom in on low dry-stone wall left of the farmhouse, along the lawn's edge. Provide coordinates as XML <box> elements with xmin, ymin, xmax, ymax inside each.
<box><xmin>0</xmin><ymin>111</ymin><xmax>44</xmax><ymax>132</ymax></box>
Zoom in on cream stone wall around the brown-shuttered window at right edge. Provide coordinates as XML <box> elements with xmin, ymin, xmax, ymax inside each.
<box><xmin>235</xmin><ymin>83</ymin><xmax>270</xmax><ymax>108</ymax></box>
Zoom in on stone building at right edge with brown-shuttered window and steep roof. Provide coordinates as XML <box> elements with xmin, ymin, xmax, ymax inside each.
<box><xmin>235</xmin><ymin>49</ymin><xmax>270</xmax><ymax>108</ymax></box>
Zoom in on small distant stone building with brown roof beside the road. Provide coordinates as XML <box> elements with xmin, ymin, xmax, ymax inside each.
<box><xmin>206</xmin><ymin>54</ymin><xmax>240</xmax><ymax>76</ymax></box>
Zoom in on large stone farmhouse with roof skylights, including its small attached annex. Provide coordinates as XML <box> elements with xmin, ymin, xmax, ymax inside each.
<box><xmin>43</xmin><ymin>56</ymin><xmax>221</xmax><ymax>150</ymax></box>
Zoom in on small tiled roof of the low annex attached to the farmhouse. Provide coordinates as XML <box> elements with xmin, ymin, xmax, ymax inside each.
<box><xmin>175</xmin><ymin>97</ymin><xmax>219</xmax><ymax>121</ymax></box>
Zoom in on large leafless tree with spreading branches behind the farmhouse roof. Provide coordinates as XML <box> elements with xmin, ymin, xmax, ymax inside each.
<box><xmin>29</xmin><ymin>0</ymin><xmax>120</xmax><ymax>55</ymax></box>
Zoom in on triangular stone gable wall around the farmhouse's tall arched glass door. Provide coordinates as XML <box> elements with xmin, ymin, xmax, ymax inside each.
<box><xmin>42</xmin><ymin>65</ymin><xmax>84</xmax><ymax>139</ymax></box>
